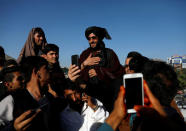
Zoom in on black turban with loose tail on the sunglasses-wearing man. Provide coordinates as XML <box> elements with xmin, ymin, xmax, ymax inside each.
<box><xmin>85</xmin><ymin>26</ymin><xmax>111</xmax><ymax>40</ymax></box>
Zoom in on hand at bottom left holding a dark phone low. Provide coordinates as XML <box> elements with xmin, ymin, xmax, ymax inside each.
<box><xmin>14</xmin><ymin>109</ymin><xmax>41</xmax><ymax>131</ymax></box>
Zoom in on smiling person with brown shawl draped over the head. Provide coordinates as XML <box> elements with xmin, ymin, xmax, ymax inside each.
<box><xmin>17</xmin><ymin>27</ymin><xmax>47</xmax><ymax>63</ymax></box>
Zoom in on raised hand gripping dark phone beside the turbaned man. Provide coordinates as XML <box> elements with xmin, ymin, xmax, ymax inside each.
<box><xmin>68</xmin><ymin>65</ymin><xmax>81</xmax><ymax>82</ymax></box>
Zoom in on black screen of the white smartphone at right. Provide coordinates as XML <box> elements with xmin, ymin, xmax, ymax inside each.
<box><xmin>125</xmin><ymin>77</ymin><xmax>143</xmax><ymax>109</ymax></box>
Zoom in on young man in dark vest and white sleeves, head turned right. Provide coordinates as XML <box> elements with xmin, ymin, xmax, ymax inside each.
<box><xmin>0</xmin><ymin>56</ymin><xmax>63</xmax><ymax>131</ymax></box>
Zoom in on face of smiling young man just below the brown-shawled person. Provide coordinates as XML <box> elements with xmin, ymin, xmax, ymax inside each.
<box><xmin>44</xmin><ymin>51</ymin><xmax>59</xmax><ymax>64</ymax></box>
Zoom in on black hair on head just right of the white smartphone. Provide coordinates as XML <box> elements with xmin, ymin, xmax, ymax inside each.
<box><xmin>143</xmin><ymin>60</ymin><xmax>179</xmax><ymax>106</ymax></box>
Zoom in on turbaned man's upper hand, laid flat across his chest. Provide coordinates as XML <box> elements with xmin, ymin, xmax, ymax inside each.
<box><xmin>81</xmin><ymin>54</ymin><xmax>101</xmax><ymax>68</ymax></box>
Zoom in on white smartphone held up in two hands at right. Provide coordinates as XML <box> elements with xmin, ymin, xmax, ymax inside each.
<box><xmin>123</xmin><ymin>73</ymin><xmax>144</xmax><ymax>113</ymax></box>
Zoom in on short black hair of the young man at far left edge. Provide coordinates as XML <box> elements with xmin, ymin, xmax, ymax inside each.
<box><xmin>1</xmin><ymin>66</ymin><xmax>20</xmax><ymax>82</ymax></box>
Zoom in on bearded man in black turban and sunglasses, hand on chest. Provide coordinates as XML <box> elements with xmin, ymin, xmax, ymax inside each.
<box><xmin>79</xmin><ymin>26</ymin><xmax>123</xmax><ymax>112</ymax></box>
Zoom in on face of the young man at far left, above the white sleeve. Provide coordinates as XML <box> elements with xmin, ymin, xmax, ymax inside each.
<box><xmin>6</xmin><ymin>72</ymin><xmax>23</xmax><ymax>91</ymax></box>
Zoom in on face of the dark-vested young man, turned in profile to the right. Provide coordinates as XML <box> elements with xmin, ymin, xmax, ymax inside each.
<box><xmin>37</xmin><ymin>65</ymin><xmax>50</xmax><ymax>87</ymax></box>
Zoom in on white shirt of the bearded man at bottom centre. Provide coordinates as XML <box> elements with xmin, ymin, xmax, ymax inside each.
<box><xmin>60</xmin><ymin>99</ymin><xmax>109</xmax><ymax>131</ymax></box>
